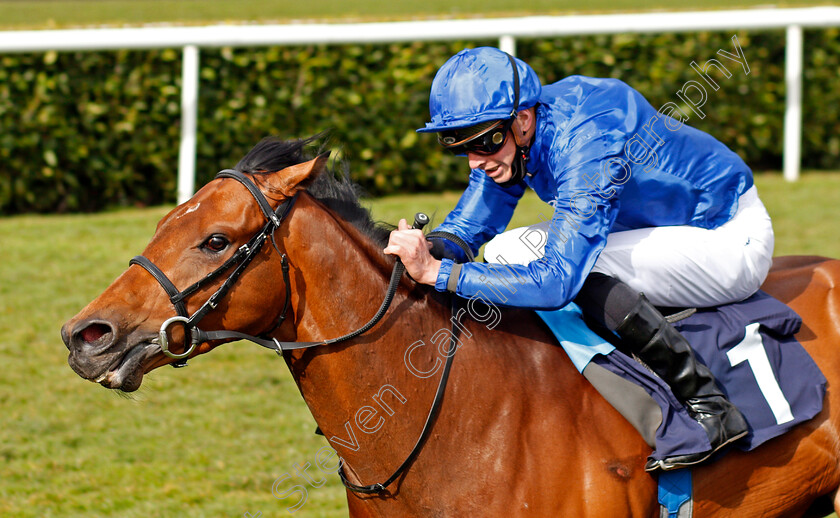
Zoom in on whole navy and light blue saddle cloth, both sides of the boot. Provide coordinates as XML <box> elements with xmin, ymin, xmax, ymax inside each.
<box><xmin>537</xmin><ymin>291</ymin><xmax>826</xmax><ymax>459</ymax></box>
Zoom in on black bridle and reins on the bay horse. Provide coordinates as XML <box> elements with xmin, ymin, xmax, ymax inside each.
<box><xmin>135</xmin><ymin>169</ymin><xmax>472</xmax><ymax>493</ymax></box>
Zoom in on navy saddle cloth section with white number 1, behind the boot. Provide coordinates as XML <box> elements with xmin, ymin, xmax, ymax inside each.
<box><xmin>675</xmin><ymin>291</ymin><xmax>827</xmax><ymax>450</ymax></box>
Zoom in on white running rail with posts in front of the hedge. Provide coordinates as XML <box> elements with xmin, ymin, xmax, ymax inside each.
<box><xmin>0</xmin><ymin>6</ymin><xmax>840</xmax><ymax>203</ymax></box>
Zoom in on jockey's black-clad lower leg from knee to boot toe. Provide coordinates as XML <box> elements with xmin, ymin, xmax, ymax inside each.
<box><xmin>575</xmin><ymin>273</ymin><xmax>748</xmax><ymax>471</ymax></box>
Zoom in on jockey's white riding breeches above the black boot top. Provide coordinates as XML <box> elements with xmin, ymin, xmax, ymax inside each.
<box><xmin>484</xmin><ymin>186</ymin><xmax>774</xmax><ymax>307</ymax></box>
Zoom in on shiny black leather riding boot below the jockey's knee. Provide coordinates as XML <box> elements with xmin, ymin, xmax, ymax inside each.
<box><xmin>615</xmin><ymin>295</ymin><xmax>748</xmax><ymax>471</ymax></box>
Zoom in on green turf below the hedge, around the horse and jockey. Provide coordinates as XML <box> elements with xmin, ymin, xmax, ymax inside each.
<box><xmin>0</xmin><ymin>173</ymin><xmax>840</xmax><ymax>518</ymax></box>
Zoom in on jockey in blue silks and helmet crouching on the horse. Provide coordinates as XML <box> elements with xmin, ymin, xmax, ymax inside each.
<box><xmin>385</xmin><ymin>47</ymin><xmax>773</xmax><ymax>471</ymax></box>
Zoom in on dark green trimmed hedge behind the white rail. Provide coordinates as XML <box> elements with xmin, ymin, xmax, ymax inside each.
<box><xmin>0</xmin><ymin>29</ymin><xmax>840</xmax><ymax>214</ymax></box>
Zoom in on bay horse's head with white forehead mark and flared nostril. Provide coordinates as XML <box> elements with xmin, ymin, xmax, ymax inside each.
<box><xmin>61</xmin><ymin>140</ymin><xmax>326</xmax><ymax>391</ymax></box>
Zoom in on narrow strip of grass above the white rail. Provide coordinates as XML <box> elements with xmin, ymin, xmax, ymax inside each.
<box><xmin>0</xmin><ymin>0</ymin><xmax>831</xmax><ymax>28</ymax></box>
